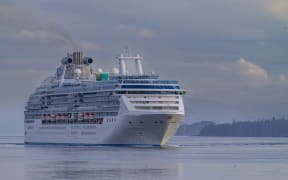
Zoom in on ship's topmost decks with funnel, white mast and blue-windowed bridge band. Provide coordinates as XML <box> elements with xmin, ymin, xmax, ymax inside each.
<box><xmin>36</xmin><ymin>49</ymin><xmax>183</xmax><ymax>93</ymax></box>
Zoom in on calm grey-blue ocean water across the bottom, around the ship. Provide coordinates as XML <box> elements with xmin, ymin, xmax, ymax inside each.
<box><xmin>0</xmin><ymin>137</ymin><xmax>288</xmax><ymax>180</ymax></box>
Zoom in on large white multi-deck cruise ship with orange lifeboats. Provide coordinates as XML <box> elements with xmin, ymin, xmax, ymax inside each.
<box><xmin>24</xmin><ymin>52</ymin><xmax>185</xmax><ymax>146</ymax></box>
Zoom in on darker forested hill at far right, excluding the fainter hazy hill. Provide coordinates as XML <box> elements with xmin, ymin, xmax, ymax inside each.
<box><xmin>200</xmin><ymin>118</ymin><xmax>288</xmax><ymax>137</ymax></box>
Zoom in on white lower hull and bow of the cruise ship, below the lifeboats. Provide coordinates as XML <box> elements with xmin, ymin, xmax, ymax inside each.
<box><xmin>25</xmin><ymin>113</ymin><xmax>183</xmax><ymax>146</ymax></box>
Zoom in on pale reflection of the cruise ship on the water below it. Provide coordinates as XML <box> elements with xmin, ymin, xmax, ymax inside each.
<box><xmin>26</xmin><ymin>147</ymin><xmax>178</xmax><ymax>180</ymax></box>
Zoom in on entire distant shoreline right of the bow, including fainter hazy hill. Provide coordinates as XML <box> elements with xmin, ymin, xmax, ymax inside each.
<box><xmin>176</xmin><ymin>118</ymin><xmax>288</xmax><ymax>137</ymax></box>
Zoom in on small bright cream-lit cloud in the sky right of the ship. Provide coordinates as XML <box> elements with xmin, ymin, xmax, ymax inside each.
<box><xmin>237</xmin><ymin>58</ymin><xmax>269</xmax><ymax>80</ymax></box>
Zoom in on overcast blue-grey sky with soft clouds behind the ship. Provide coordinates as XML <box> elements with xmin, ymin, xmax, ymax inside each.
<box><xmin>0</xmin><ymin>0</ymin><xmax>288</xmax><ymax>132</ymax></box>
